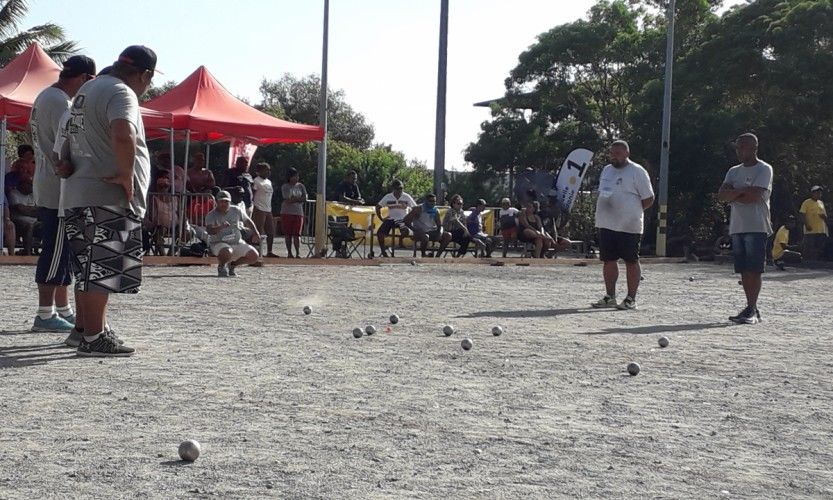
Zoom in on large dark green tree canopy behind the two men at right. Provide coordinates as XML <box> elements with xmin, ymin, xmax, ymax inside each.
<box><xmin>466</xmin><ymin>0</ymin><xmax>833</xmax><ymax>244</ymax></box>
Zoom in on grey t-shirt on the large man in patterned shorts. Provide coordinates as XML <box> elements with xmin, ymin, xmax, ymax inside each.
<box><xmin>63</xmin><ymin>75</ymin><xmax>150</xmax><ymax>217</ymax></box>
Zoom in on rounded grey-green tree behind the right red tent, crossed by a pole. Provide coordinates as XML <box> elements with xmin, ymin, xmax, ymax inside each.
<box><xmin>259</xmin><ymin>74</ymin><xmax>375</xmax><ymax>149</ymax></box>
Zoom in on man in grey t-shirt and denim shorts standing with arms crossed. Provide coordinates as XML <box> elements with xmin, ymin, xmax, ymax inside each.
<box><xmin>717</xmin><ymin>133</ymin><xmax>772</xmax><ymax>324</ymax></box>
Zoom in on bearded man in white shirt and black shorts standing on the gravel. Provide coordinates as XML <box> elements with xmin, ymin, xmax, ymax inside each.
<box><xmin>591</xmin><ymin>141</ymin><xmax>654</xmax><ymax>309</ymax></box>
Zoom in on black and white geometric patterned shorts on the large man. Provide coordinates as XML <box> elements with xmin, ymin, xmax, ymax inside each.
<box><xmin>65</xmin><ymin>206</ymin><xmax>143</xmax><ymax>293</ymax></box>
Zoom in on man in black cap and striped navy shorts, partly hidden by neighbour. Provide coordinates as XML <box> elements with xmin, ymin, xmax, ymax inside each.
<box><xmin>29</xmin><ymin>56</ymin><xmax>95</xmax><ymax>332</ymax></box>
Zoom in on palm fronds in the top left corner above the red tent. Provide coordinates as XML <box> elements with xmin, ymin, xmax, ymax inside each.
<box><xmin>0</xmin><ymin>0</ymin><xmax>78</xmax><ymax>67</ymax></box>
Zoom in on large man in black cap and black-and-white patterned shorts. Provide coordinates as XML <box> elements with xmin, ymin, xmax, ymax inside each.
<box><xmin>61</xmin><ymin>45</ymin><xmax>156</xmax><ymax>357</ymax></box>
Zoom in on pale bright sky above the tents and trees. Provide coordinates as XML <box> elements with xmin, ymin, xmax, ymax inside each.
<box><xmin>21</xmin><ymin>0</ymin><xmax>744</xmax><ymax>170</ymax></box>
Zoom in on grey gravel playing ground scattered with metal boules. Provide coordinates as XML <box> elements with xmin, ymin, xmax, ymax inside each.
<box><xmin>0</xmin><ymin>263</ymin><xmax>833</xmax><ymax>499</ymax></box>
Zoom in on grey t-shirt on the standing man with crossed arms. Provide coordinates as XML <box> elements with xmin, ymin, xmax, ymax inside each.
<box><xmin>723</xmin><ymin>160</ymin><xmax>772</xmax><ymax>235</ymax></box>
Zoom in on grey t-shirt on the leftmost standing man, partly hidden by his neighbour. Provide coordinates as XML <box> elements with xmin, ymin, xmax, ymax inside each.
<box><xmin>29</xmin><ymin>87</ymin><xmax>71</xmax><ymax>210</ymax></box>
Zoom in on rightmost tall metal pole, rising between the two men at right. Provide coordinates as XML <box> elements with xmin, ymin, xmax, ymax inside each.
<box><xmin>657</xmin><ymin>0</ymin><xmax>675</xmax><ymax>257</ymax></box>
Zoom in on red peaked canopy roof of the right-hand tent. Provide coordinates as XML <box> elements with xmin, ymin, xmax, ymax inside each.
<box><xmin>145</xmin><ymin>66</ymin><xmax>324</xmax><ymax>144</ymax></box>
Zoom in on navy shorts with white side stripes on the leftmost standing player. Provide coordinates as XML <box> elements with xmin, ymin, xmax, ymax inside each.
<box><xmin>35</xmin><ymin>207</ymin><xmax>72</xmax><ymax>286</ymax></box>
